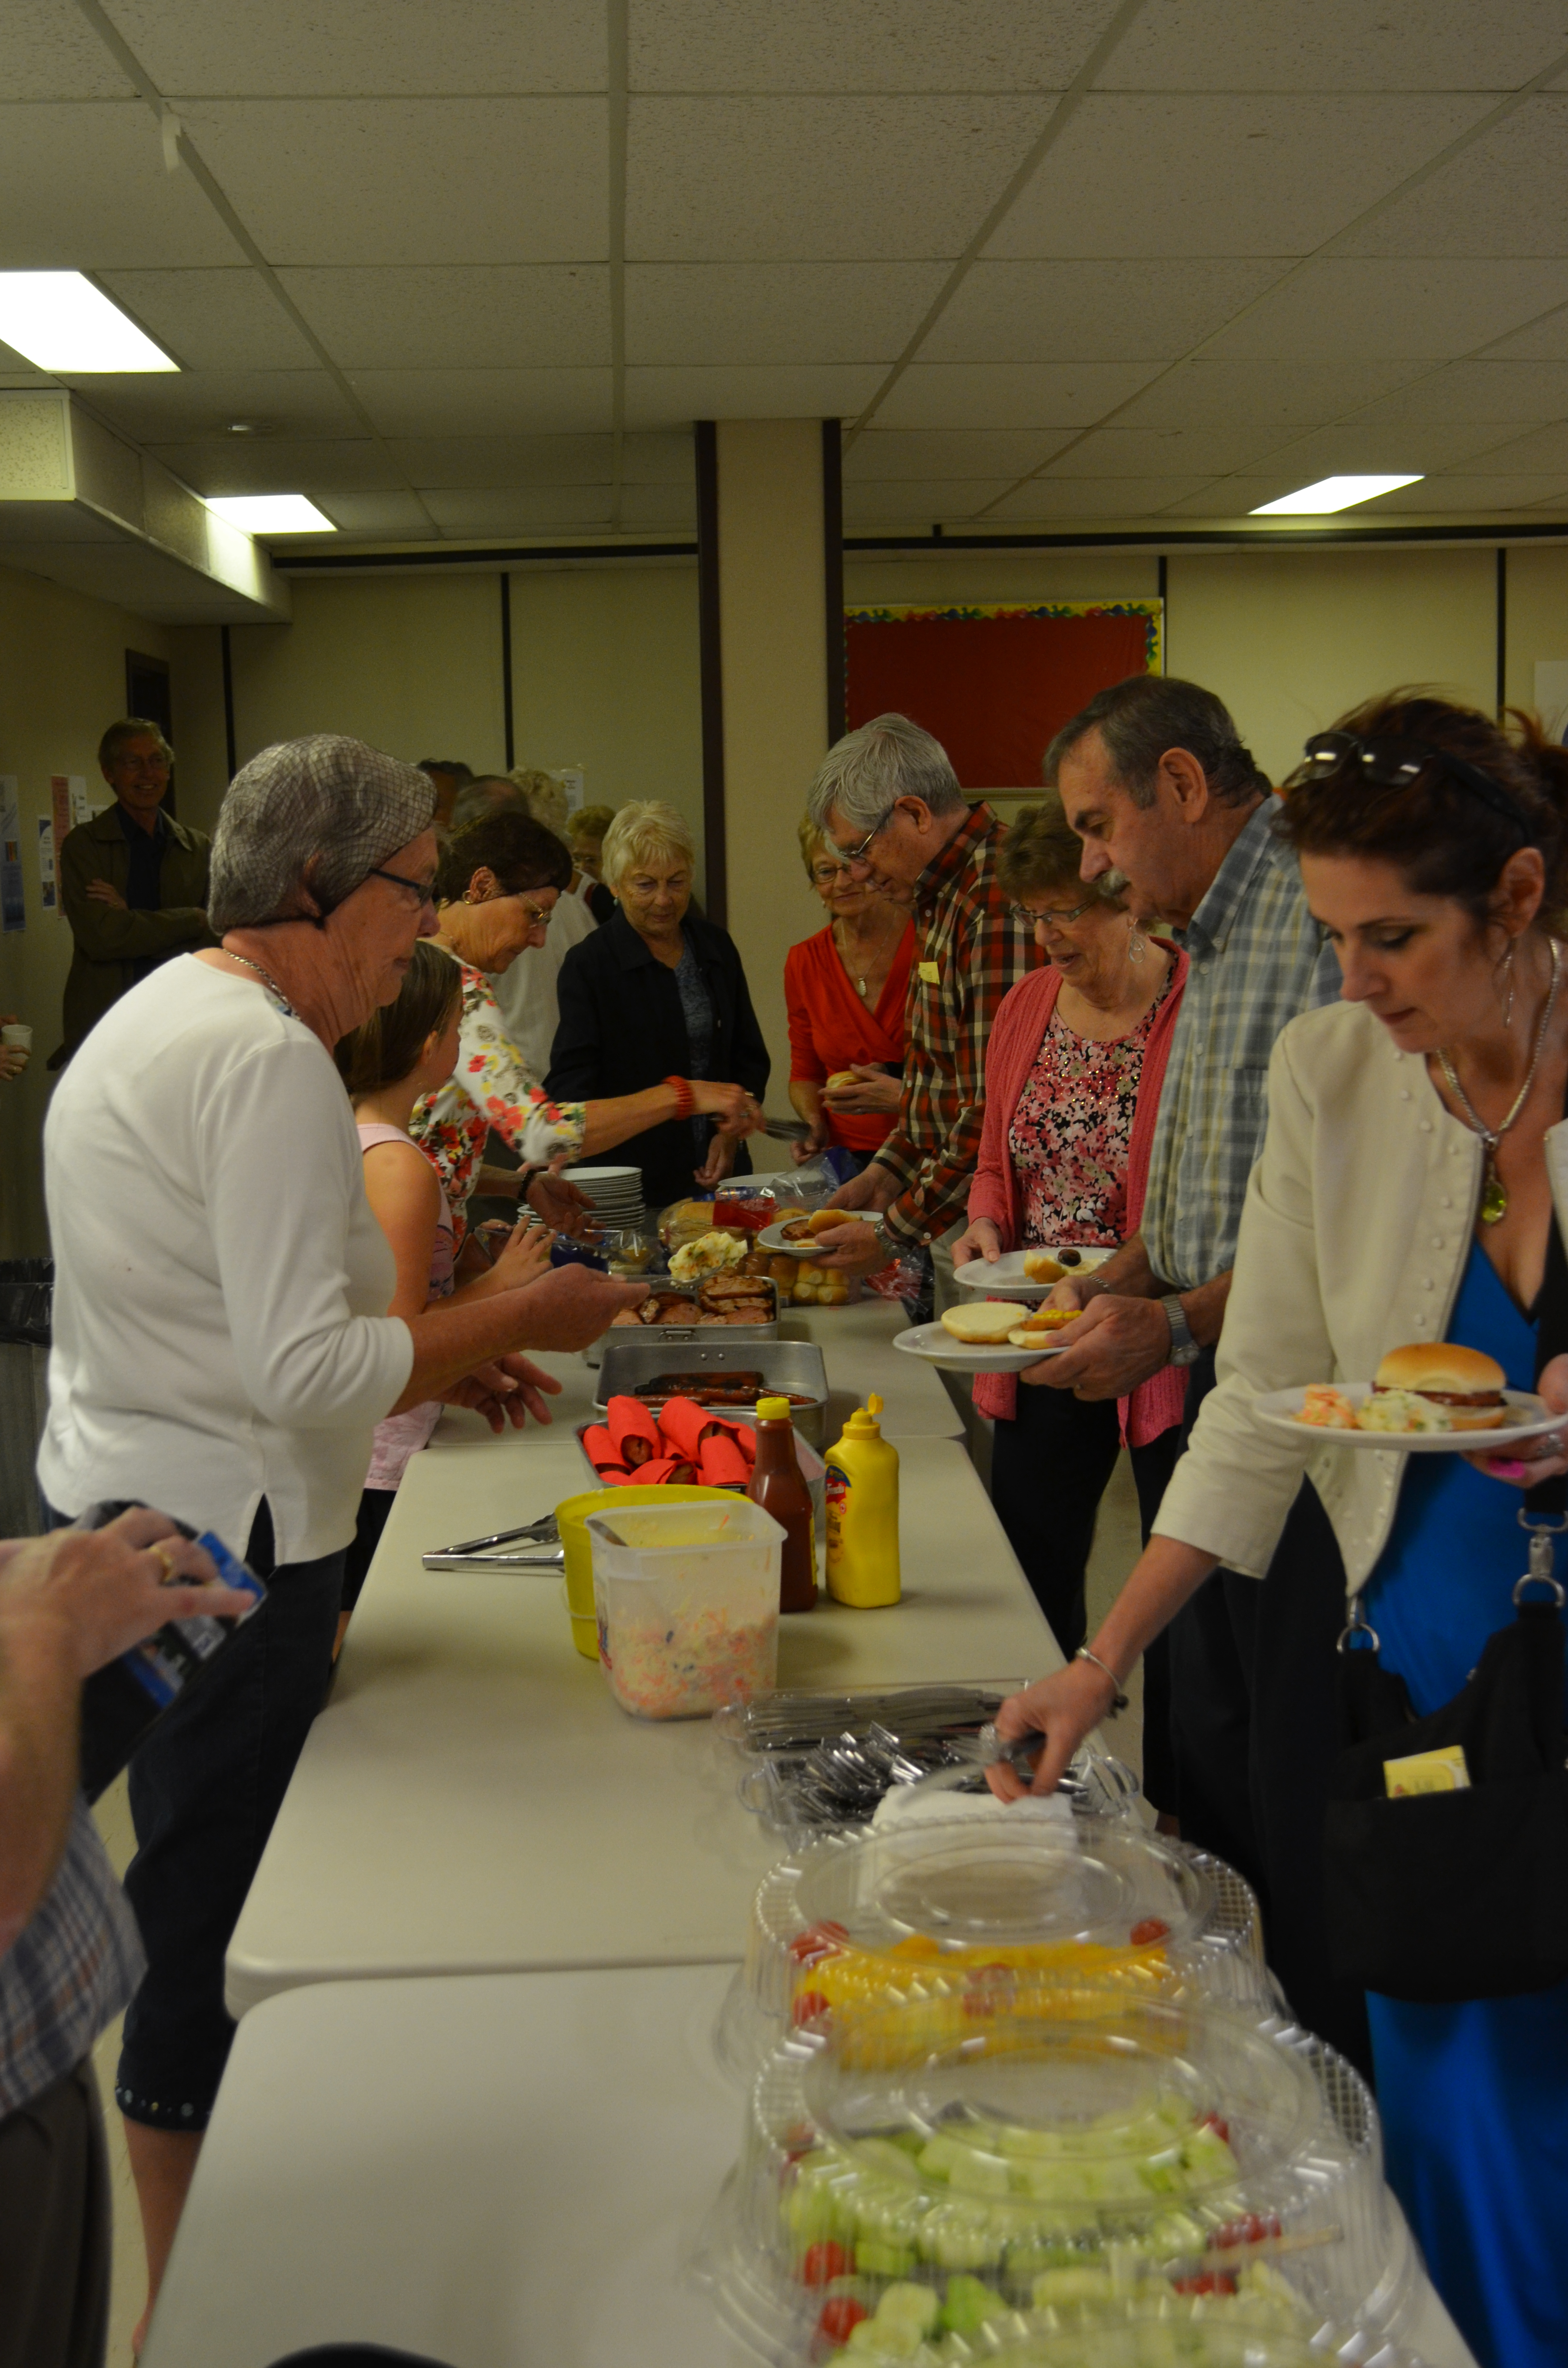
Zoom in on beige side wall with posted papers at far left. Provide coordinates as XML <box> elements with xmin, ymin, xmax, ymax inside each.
<box><xmin>0</xmin><ymin>568</ymin><xmax>168</xmax><ymax>1258</ymax></box>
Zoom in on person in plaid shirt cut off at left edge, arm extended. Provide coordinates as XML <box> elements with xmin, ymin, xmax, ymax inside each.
<box><xmin>0</xmin><ymin>1508</ymin><xmax>251</xmax><ymax>2368</ymax></box>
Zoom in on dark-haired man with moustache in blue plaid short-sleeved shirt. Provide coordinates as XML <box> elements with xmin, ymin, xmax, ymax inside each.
<box><xmin>1023</xmin><ymin>675</ymin><xmax>1367</xmax><ymax>2060</ymax></box>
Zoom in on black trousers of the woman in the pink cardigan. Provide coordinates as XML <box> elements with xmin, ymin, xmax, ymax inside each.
<box><xmin>990</xmin><ymin>1385</ymin><xmax>1182</xmax><ymax>1812</ymax></box>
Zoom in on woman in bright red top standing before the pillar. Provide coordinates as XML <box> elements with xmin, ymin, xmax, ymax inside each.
<box><xmin>784</xmin><ymin>817</ymin><xmax>914</xmax><ymax>1170</ymax></box>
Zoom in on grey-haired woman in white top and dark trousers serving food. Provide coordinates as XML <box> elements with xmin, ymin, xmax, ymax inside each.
<box><xmin>38</xmin><ymin>734</ymin><xmax>642</xmax><ymax>2330</ymax></box>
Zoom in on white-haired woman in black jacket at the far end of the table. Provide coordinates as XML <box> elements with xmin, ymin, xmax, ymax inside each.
<box><xmin>545</xmin><ymin>798</ymin><xmax>767</xmax><ymax>1208</ymax></box>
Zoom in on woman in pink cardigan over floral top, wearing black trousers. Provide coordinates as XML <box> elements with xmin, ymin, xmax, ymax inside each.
<box><xmin>952</xmin><ymin>791</ymin><xmax>1187</xmax><ymax>1809</ymax></box>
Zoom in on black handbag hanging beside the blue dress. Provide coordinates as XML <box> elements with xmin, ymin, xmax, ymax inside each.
<box><xmin>1324</xmin><ymin>1203</ymin><xmax>1568</xmax><ymax>2003</ymax></box>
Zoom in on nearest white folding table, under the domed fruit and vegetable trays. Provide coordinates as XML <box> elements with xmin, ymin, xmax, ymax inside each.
<box><xmin>142</xmin><ymin>1965</ymin><xmax>1473</xmax><ymax>2368</ymax></box>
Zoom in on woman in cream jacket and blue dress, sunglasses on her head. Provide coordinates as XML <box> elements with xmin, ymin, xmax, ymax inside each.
<box><xmin>992</xmin><ymin>694</ymin><xmax>1568</xmax><ymax>2368</ymax></box>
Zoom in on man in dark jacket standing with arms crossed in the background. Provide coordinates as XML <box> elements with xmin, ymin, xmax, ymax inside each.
<box><xmin>50</xmin><ymin>715</ymin><xmax>218</xmax><ymax>1068</ymax></box>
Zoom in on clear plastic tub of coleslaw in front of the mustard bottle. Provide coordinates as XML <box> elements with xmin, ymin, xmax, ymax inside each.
<box><xmin>588</xmin><ymin>1490</ymin><xmax>784</xmax><ymax>1719</ymax></box>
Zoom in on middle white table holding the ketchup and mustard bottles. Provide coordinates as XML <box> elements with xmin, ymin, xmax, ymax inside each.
<box><xmin>227</xmin><ymin>1305</ymin><xmax>1059</xmax><ymax>2015</ymax></box>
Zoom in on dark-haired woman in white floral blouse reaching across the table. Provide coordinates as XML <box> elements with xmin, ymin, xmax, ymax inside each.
<box><xmin>410</xmin><ymin>810</ymin><xmax>763</xmax><ymax>1238</ymax></box>
